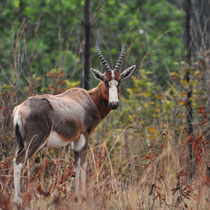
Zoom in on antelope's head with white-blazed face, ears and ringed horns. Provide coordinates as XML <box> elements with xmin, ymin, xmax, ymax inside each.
<box><xmin>91</xmin><ymin>40</ymin><xmax>136</xmax><ymax>109</ymax></box>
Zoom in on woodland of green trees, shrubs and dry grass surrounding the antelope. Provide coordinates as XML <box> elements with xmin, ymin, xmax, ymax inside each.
<box><xmin>0</xmin><ymin>0</ymin><xmax>210</xmax><ymax>209</ymax></box>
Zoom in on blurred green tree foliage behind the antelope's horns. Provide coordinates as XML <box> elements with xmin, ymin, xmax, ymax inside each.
<box><xmin>0</xmin><ymin>0</ymin><xmax>183</xmax><ymax>92</ymax></box>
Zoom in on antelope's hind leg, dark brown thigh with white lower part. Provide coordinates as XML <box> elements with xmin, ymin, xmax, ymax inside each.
<box><xmin>13</xmin><ymin>103</ymin><xmax>52</xmax><ymax>203</ymax></box>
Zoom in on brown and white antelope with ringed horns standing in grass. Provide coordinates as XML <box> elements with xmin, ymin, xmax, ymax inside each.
<box><xmin>13</xmin><ymin>41</ymin><xmax>136</xmax><ymax>203</ymax></box>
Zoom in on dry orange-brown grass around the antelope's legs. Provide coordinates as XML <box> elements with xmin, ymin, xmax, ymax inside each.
<box><xmin>0</xmin><ymin>119</ymin><xmax>210</xmax><ymax>210</ymax></box>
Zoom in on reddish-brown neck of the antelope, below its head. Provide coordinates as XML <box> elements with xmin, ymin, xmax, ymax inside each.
<box><xmin>88</xmin><ymin>82</ymin><xmax>111</xmax><ymax>120</ymax></box>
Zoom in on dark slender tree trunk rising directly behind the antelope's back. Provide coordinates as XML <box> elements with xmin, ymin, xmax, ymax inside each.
<box><xmin>82</xmin><ymin>0</ymin><xmax>91</xmax><ymax>90</ymax></box>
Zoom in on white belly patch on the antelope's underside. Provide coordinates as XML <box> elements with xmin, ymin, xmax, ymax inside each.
<box><xmin>47</xmin><ymin>131</ymin><xmax>70</xmax><ymax>148</ymax></box>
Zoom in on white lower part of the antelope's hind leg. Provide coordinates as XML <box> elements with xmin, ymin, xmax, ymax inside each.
<box><xmin>13</xmin><ymin>159</ymin><xmax>23</xmax><ymax>203</ymax></box>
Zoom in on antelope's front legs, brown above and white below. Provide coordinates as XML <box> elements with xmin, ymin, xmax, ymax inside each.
<box><xmin>72</xmin><ymin>134</ymin><xmax>88</xmax><ymax>197</ymax></box>
